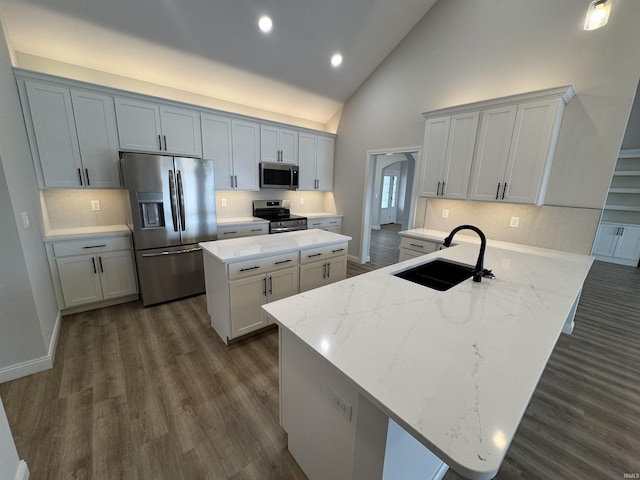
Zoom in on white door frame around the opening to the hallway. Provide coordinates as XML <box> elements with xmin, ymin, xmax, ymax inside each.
<box><xmin>358</xmin><ymin>146</ymin><xmax>422</xmax><ymax>264</ymax></box>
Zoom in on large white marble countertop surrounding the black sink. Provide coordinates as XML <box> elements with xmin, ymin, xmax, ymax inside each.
<box><xmin>263</xmin><ymin>244</ymin><xmax>593</xmax><ymax>479</ymax></box>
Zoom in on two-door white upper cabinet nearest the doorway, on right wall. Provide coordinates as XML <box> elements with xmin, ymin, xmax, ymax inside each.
<box><xmin>420</xmin><ymin>112</ymin><xmax>479</xmax><ymax>199</ymax></box>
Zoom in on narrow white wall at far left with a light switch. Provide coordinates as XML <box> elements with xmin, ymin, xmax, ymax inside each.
<box><xmin>0</xmin><ymin>23</ymin><xmax>59</xmax><ymax>379</ymax></box>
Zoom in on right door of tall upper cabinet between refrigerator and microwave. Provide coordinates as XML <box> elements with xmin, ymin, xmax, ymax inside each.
<box><xmin>231</xmin><ymin>120</ymin><xmax>260</xmax><ymax>190</ymax></box>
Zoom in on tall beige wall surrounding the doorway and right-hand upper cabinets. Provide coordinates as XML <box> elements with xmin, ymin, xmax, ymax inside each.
<box><xmin>334</xmin><ymin>0</ymin><xmax>640</xmax><ymax>255</ymax></box>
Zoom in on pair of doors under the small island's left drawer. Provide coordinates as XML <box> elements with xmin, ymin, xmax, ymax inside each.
<box><xmin>229</xmin><ymin>267</ymin><xmax>298</xmax><ymax>337</ymax></box>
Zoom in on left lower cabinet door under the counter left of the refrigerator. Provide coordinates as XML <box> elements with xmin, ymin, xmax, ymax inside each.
<box><xmin>56</xmin><ymin>255</ymin><xmax>103</xmax><ymax>308</ymax></box>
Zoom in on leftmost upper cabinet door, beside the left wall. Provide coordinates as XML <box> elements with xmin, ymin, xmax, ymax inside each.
<box><xmin>25</xmin><ymin>82</ymin><xmax>85</xmax><ymax>188</ymax></box>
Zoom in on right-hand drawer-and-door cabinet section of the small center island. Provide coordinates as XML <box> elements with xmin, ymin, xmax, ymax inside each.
<box><xmin>300</xmin><ymin>244</ymin><xmax>347</xmax><ymax>292</ymax></box>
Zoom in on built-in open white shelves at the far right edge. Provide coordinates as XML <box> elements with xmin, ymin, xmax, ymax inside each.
<box><xmin>602</xmin><ymin>149</ymin><xmax>640</xmax><ymax>225</ymax></box>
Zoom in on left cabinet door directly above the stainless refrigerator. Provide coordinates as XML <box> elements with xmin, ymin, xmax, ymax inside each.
<box><xmin>115</xmin><ymin>98</ymin><xmax>164</xmax><ymax>152</ymax></box>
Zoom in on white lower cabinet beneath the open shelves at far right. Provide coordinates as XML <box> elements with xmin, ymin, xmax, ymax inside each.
<box><xmin>593</xmin><ymin>223</ymin><xmax>640</xmax><ymax>267</ymax></box>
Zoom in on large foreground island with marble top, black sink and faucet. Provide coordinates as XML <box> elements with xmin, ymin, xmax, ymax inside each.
<box><xmin>263</xmin><ymin>243</ymin><xmax>593</xmax><ymax>480</ymax></box>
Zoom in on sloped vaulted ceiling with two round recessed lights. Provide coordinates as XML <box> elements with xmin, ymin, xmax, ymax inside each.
<box><xmin>0</xmin><ymin>0</ymin><xmax>436</xmax><ymax>124</ymax></box>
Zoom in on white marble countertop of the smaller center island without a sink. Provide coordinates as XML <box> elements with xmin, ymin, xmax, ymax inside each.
<box><xmin>200</xmin><ymin>229</ymin><xmax>351</xmax><ymax>263</ymax></box>
